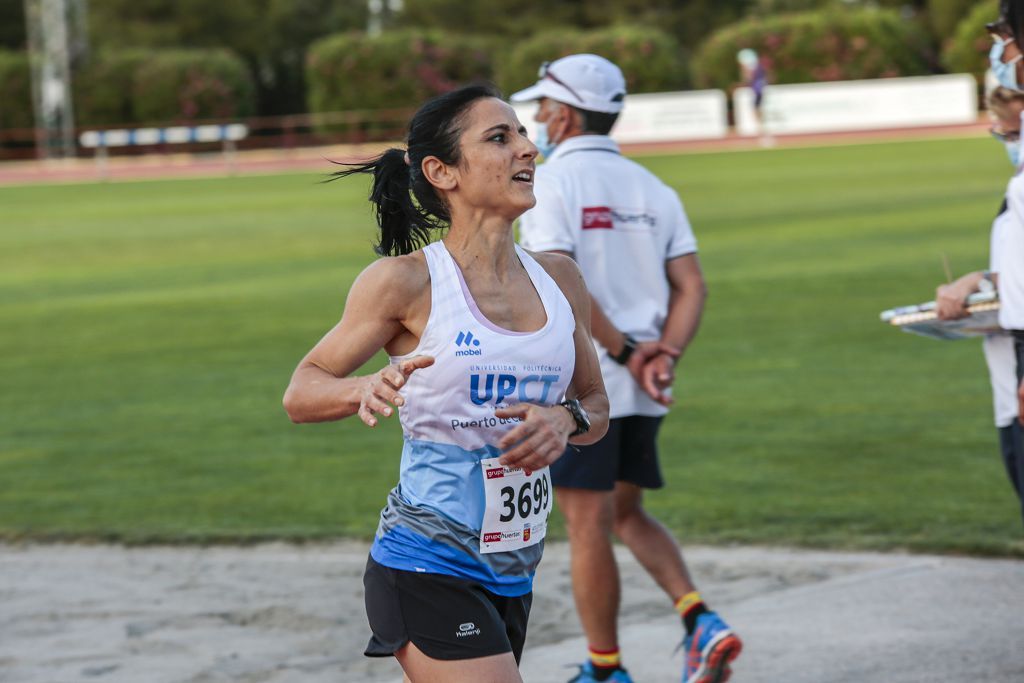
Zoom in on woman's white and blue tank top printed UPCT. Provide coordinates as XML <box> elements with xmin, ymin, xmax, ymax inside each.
<box><xmin>371</xmin><ymin>242</ymin><xmax>575</xmax><ymax>597</ymax></box>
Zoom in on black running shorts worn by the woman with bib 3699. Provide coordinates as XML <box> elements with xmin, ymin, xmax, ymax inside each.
<box><xmin>362</xmin><ymin>557</ymin><xmax>534</xmax><ymax>663</ymax></box>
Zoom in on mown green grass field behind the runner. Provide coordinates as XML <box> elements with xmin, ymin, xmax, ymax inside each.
<box><xmin>0</xmin><ymin>139</ymin><xmax>1024</xmax><ymax>556</ymax></box>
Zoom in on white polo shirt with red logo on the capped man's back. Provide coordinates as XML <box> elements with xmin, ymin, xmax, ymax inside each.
<box><xmin>519</xmin><ymin>135</ymin><xmax>697</xmax><ymax>418</ymax></box>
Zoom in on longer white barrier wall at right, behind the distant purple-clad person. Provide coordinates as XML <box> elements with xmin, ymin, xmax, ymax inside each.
<box><xmin>732</xmin><ymin>74</ymin><xmax>978</xmax><ymax>135</ymax></box>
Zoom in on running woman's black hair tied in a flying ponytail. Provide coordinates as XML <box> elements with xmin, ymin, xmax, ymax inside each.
<box><xmin>329</xmin><ymin>83</ymin><xmax>502</xmax><ymax>256</ymax></box>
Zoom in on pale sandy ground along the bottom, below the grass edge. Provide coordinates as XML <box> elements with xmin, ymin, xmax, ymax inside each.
<box><xmin>0</xmin><ymin>543</ymin><xmax>1024</xmax><ymax>683</ymax></box>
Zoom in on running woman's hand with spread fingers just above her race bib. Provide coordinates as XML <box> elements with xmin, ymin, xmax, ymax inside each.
<box><xmin>495</xmin><ymin>403</ymin><xmax>577</xmax><ymax>471</ymax></box>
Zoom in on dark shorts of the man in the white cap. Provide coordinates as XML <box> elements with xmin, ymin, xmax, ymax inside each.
<box><xmin>551</xmin><ymin>415</ymin><xmax>665</xmax><ymax>490</ymax></box>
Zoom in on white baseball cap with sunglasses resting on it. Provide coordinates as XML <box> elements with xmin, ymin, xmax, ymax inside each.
<box><xmin>509</xmin><ymin>54</ymin><xmax>626</xmax><ymax>114</ymax></box>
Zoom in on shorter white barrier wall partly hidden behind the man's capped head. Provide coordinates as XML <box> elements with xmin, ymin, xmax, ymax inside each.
<box><xmin>512</xmin><ymin>90</ymin><xmax>728</xmax><ymax>142</ymax></box>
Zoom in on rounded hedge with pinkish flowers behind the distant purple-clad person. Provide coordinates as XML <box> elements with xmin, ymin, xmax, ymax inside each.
<box><xmin>692</xmin><ymin>7</ymin><xmax>934</xmax><ymax>88</ymax></box>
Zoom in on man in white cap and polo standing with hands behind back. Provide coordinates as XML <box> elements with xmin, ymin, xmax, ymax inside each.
<box><xmin>511</xmin><ymin>54</ymin><xmax>742</xmax><ymax>683</ymax></box>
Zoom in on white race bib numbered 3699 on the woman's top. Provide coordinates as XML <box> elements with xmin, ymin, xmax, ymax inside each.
<box><xmin>480</xmin><ymin>458</ymin><xmax>554</xmax><ymax>553</ymax></box>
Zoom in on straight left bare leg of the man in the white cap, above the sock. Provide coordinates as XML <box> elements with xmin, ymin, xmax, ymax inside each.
<box><xmin>555</xmin><ymin>486</ymin><xmax>620</xmax><ymax>651</ymax></box>
